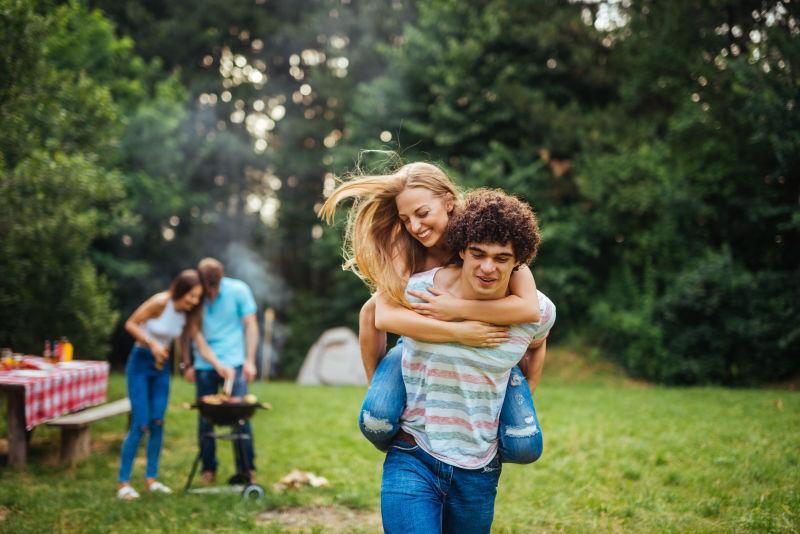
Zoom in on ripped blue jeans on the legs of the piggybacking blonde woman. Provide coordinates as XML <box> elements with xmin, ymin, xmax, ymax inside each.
<box><xmin>358</xmin><ymin>344</ymin><xmax>544</xmax><ymax>464</ymax></box>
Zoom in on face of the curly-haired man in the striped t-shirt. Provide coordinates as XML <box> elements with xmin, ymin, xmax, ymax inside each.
<box><xmin>459</xmin><ymin>242</ymin><xmax>517</xmax><ymax>300</ymax></box>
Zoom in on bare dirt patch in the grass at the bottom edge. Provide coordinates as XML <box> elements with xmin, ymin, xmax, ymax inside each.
<box><xmin>256</xmin><ymin>506</ymin><xmax>381</xmax><ymax>532</ymax></box>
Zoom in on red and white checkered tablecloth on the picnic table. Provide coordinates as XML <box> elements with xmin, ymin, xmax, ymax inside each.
<box><xmin>0</xmin><ymin>356</ymin><xmax>109</xmax><ymax>430</ymax></box>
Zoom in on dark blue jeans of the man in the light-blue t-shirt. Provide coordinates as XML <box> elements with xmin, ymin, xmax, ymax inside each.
<box><xmin>195</xmin><ymin>365</ymin><xmax>256</xmax><ymax>473</ymax></box>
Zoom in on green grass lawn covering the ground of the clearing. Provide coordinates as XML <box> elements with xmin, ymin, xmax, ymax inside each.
<box><xmin>0</xmin><ymin>349</ymin><xmax>800</xmax><ymax>533</ymax></box>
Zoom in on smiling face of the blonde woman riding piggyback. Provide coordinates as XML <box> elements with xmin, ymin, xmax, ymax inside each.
<box><xmin>395</xmin><ymin>187</ymin><xmax>454</xmax><ymax>247</ymax></box>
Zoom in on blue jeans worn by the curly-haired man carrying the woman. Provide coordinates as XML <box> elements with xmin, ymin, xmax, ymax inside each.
<box><xmin>381</xmin><ymin>441</ymin><xmax>502</xmax><ymax>534</ymax></box>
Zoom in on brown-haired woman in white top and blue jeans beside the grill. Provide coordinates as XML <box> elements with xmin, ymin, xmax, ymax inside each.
<box><xmin>117</xmin><ymin>269</ymin><xmax>231</xmax><ymax>500</ymax></box>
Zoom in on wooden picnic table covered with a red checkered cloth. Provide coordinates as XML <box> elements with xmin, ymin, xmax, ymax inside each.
<box><xmin>0</xmin><ymin>356</ymin><xmax>109</xmax><ymax>467</ymax></box>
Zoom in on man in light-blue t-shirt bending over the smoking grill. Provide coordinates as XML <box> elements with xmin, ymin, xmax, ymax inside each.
<box><xmin>182</xmin><ymin>258</ymin><xmax>258</xmax><ymax>484</ymax></box>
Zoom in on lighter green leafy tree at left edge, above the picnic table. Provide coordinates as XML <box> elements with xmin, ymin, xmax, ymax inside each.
<box><xmin>0</xmin><ymin>0</ymin><xmax>138</xmax><ymax>358</ymax></box>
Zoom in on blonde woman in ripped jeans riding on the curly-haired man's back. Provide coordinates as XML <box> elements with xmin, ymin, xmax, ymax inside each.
<box><xmin>320</xmin><ymin>163</ymin><xmax>552</xmax><ymax>463</ymax></box>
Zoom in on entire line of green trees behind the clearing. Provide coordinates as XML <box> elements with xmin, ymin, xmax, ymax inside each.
<box><xmin>0</xmin><ymin>0</ymin><xmax>800</xmax><ymax>384</ymax></box>
